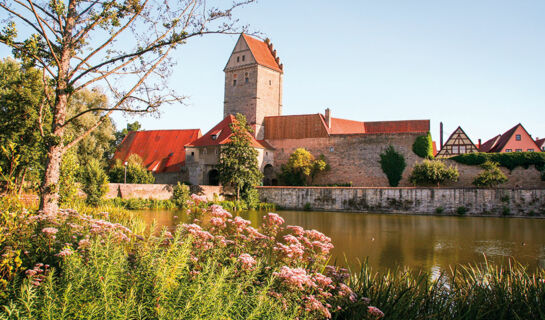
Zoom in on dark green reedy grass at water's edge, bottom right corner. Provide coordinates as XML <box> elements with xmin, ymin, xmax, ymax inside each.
<box><xmin>339</xmin><ymin>260</ymin><xmax>545</xmax><ymax>320</ymax></box>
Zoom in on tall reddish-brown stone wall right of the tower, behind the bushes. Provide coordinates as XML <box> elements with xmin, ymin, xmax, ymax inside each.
<box><xmin>268</xmin><ymin>133</ymin><xmax>422</xmax><ymax>187</ymax></box>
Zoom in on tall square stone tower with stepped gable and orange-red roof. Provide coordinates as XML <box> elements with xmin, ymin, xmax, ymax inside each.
<box><xmin>223</xmin><ymin>34</ymin><xmax>283</xmax><ymax>139</ymax></box>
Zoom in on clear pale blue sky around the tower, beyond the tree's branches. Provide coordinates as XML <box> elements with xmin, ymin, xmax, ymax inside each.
<box><xmin>0</xmin><ymin>0</ymin><xmax>545</xmax><ymax>143</ymax></box>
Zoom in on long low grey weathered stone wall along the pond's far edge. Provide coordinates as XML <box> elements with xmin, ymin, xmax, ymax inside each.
<box><xmin>258</xmin><ymin>187</ymin><xmax>545</xmax><ymax>216</ymax></box>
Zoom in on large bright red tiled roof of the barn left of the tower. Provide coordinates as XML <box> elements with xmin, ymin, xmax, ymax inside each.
<box><xmin>113</xmin><ymin>129</ymin><xmax>201</xmax><ymax>172</ymax></box>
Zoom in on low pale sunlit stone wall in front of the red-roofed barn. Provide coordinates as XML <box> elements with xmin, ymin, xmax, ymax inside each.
<box><xmin>104</xmin><ymin>183</ymin><xmax>223</xmax><ymax>200</ymax></box>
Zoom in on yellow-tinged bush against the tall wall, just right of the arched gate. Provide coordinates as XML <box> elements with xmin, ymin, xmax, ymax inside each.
<box><xmin>281</xmin><ymin>148</ymin><xmax>329</xmax><ymax>186</ymax></box>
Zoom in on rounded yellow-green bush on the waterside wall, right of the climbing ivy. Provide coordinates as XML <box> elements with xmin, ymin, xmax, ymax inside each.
<box><xmin>409</xmin><ymin>160</ymin><xmax>459</xmax><ymax>186</ymax></box>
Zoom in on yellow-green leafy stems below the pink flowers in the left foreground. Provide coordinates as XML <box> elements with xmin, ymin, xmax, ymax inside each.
<box><xmin>0</xmin><ymin>234</ymin><xmax>301</xmax><ymax>319</ymax></box>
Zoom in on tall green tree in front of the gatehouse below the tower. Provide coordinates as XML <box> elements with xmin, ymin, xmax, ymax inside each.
<box><xmin>217</xmin><ymin>113</ymin><xmax>263</xmax><ymax>200</ymax></box>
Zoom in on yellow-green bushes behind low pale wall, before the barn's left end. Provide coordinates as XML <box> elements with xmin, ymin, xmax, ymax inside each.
<box><xmin>108</xmin><ymin>154</ymin><xmax>155</xmax><ymax>184</ymax></box>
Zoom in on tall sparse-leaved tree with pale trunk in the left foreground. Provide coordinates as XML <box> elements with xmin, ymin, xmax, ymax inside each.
<box><xmin>0</xmin><ymin>0</ymin><xmax>254</xmax><ymax>213</ymax></box>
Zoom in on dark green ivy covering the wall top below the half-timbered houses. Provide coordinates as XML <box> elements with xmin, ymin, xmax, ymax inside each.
<box><xmin>450</xmin><ymin>152</ymin><xmax>545</xmax><ymax>170</ymax></box>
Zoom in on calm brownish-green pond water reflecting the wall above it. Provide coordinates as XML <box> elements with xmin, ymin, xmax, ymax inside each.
<box><xmin>136</xmin><ymin>211</ymin><xmax>545</xmax><ymax>272</ymax></box>
